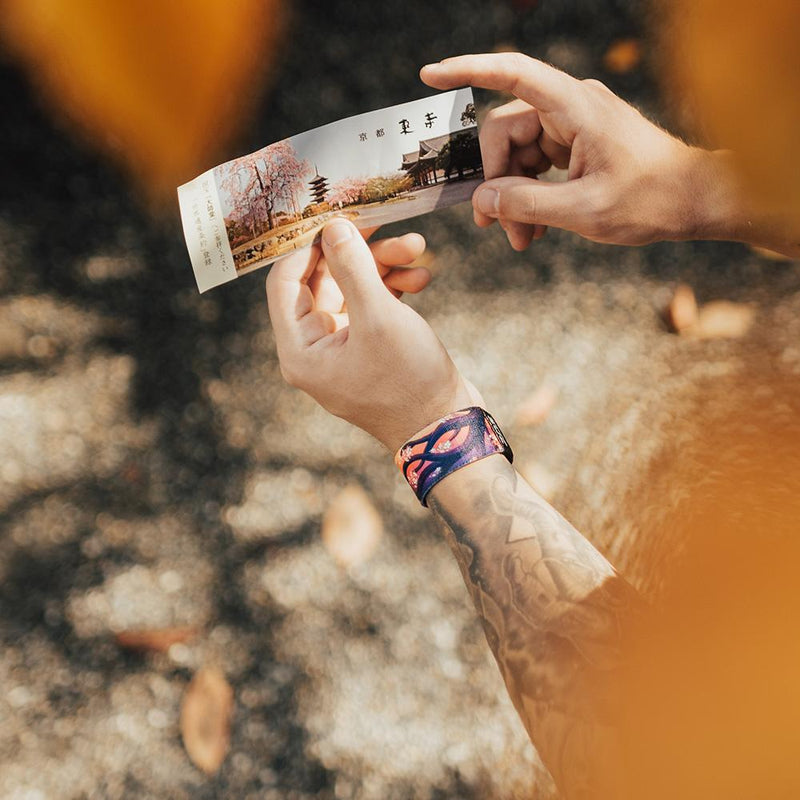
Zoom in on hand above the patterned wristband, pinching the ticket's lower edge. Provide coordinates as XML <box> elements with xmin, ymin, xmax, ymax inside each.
<box><xmin>267</xmin><ymin>219</ymin><xmax>481</xmax><ymax>451</ymax></box>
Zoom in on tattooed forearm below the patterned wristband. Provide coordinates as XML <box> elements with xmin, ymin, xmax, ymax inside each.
<box><xmin>428</xmin><ymin>456</ymin><xmax>641</xmax><ymax>798</ymax></box>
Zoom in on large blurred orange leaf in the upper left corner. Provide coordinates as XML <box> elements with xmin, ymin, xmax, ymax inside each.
<box><xmin>0</xmin><ymin>0</ymin><xmax>283</xmax><ymax>199</ymax></box>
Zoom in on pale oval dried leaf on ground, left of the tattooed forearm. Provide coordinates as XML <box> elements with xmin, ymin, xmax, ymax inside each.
<box><xmin>322</xmin><ymin>485</ymin><xmax>383</xmax><ymax>567</ymax></box>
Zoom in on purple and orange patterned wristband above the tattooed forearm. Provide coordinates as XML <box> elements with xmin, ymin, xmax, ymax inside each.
<box><xmin>394</xmin><ymin>406</ymin><xmax>514</xmax><ymax>506</ymax></box>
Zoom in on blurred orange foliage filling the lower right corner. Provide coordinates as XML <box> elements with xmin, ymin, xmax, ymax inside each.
<box><xmin>620</xmin><ymin>372</ymin><xmax>800</xmax><ymax>800</ymax></box>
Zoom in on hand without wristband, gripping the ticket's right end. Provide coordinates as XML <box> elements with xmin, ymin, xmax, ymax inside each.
<box><xmin>420</xmin><ymin>53</ymin><xmax>717</xmax><ymax>250</ymax></box>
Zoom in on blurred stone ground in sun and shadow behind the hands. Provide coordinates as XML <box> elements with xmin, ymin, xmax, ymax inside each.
<box><xmin>0</xmin><ymin>0</ymin><xmax>800</xmax><ymax>800</ymax></box>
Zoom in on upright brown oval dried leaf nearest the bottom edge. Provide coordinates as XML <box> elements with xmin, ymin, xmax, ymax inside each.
<box><xmin>181</xmin><ymin>667</ymin><xmax>233</xmax><ymax>775</ymax></box>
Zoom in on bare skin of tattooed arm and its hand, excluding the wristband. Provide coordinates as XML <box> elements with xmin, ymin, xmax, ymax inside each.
<box><xmin>267</xmin><ymin>220</ymin><xmax>639</xmax><ymax>798</ymax></box>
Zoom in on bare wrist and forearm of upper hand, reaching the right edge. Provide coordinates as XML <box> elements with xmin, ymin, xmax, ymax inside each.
<box><xmin>680</xmin><ymin>148</ymin><xmax>800</xmax><ymax>258</ymax></box>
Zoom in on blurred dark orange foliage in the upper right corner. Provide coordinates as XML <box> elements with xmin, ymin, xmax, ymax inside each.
<box><xmin>667</xmin><ymin>0</ymin><xmax>800</xmax><ymax>218</ymax></box>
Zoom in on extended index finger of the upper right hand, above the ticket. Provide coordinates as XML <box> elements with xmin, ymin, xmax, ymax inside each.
<box><xmin>420</xmin><ymin>53</ymin><xmax>580</xmax><ymax>111</ymax></box>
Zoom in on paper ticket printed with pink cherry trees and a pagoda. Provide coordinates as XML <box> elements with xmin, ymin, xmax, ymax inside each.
<box><xmin>178</xmin><ymin>89</ymin><xmax>483</xmax><ymax>292</ymax></box>
